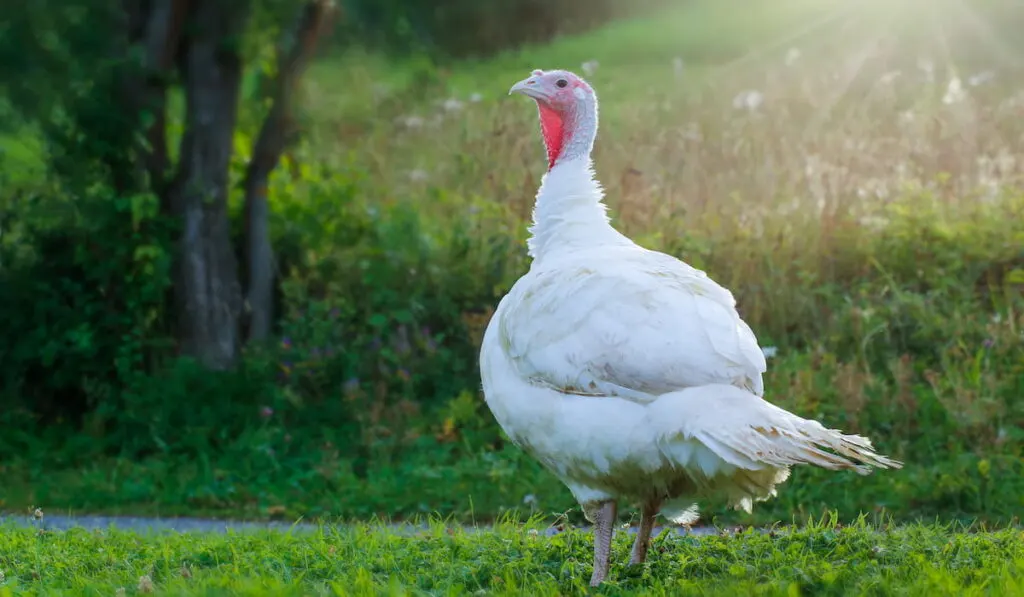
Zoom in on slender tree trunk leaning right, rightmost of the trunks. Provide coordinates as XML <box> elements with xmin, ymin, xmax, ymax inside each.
<box><xmin>244</xmin><ymin>0</ymin><xmax>334</xmax><ymax>342</ymax></box>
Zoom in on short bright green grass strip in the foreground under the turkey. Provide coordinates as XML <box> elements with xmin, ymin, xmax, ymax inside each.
<box><xmin>0</xmin><ymin>523</ymin><xmax>1024</xmax><ymax>597</ymax></box>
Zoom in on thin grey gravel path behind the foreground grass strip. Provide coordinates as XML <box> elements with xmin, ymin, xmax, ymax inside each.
<box><xmin>0</xmin><ymin>514</ymin><xmax>719</xmax><ymax>537</ymax></box>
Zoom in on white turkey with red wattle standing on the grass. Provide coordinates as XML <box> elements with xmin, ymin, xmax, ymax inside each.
<box><xmin>480</xmin><ymin>71</ymin><xmax>902</xmax><ymax>586</ymax></box>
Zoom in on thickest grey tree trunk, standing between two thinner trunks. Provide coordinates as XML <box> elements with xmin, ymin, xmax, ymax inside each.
<box><xmin>170</xmin><ymin>0</ymin><xmax>249</xmax><ymax>369</ymax></box>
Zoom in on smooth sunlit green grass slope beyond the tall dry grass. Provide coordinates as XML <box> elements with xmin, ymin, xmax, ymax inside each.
<box><xmin>310</xmin><ymin>0</ymin><xmax>849</xmax><ymax>96</ymax></box>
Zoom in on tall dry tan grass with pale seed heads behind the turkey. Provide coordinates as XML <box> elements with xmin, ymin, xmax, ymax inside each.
<box><xmin>303</xmin><ymin>44</ymin><xmax>1024</xmax><ymax>340</ymax></box>
